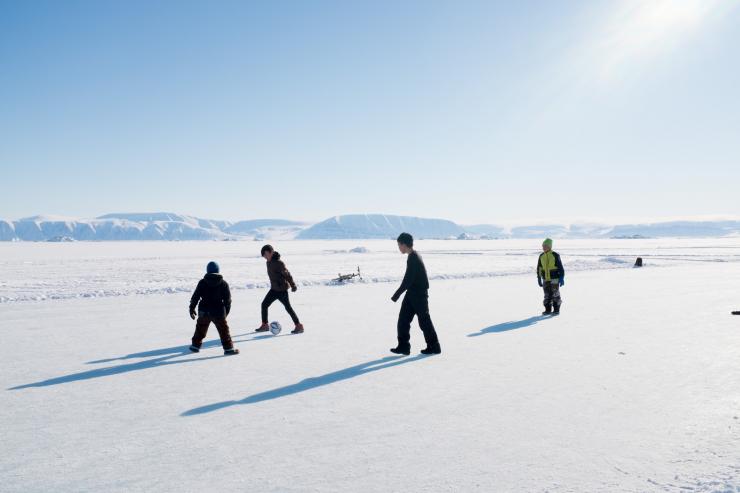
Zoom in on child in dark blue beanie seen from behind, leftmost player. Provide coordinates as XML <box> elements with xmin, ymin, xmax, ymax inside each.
<box><xmin>190</xmin><ymin>262</ymin><xmax>239</xmax><ymax>354</ymax></box>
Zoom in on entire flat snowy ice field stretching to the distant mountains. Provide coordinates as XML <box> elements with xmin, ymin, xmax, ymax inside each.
<box><xmin>0</xmin><ymin>238</ymin><xmax>740</xmax><ymax>492</ymax></box>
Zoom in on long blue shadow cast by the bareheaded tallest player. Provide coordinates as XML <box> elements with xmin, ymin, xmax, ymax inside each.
<box><xmin>181</xmin><ymin>354</ymin><xmax>428</xmax><ymax>416</ymax></box>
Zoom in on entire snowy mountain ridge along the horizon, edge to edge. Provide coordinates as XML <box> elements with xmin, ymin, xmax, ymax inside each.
<box><xmin>0</xmin><ymin>212</ymin><xmax>740</xmax><ymax>241</ymax></box>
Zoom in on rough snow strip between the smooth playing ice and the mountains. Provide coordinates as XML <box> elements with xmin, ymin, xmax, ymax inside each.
<box><xmin>0</xmin><ymin>238</ymin><xmax>740</xmax><ymax>303</ymax></box>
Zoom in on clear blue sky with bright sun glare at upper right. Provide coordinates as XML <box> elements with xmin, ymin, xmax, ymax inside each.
<box><xmin>0</xmin><ymin>0</ymin><xmax>740</xmax><ymax>224</ymax></box>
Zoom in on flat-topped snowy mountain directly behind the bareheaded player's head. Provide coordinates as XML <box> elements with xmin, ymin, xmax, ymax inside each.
<box><xmin>298</xmin><ymin>214</ymin><xmax>465</xmax><ymax>240</ymax></box>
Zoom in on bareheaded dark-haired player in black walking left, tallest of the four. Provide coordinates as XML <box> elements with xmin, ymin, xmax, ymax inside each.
<box><xmin>391</xmin><ymin>233</ymin><xmax>442</xmax><ymax>355</ymax></box>
